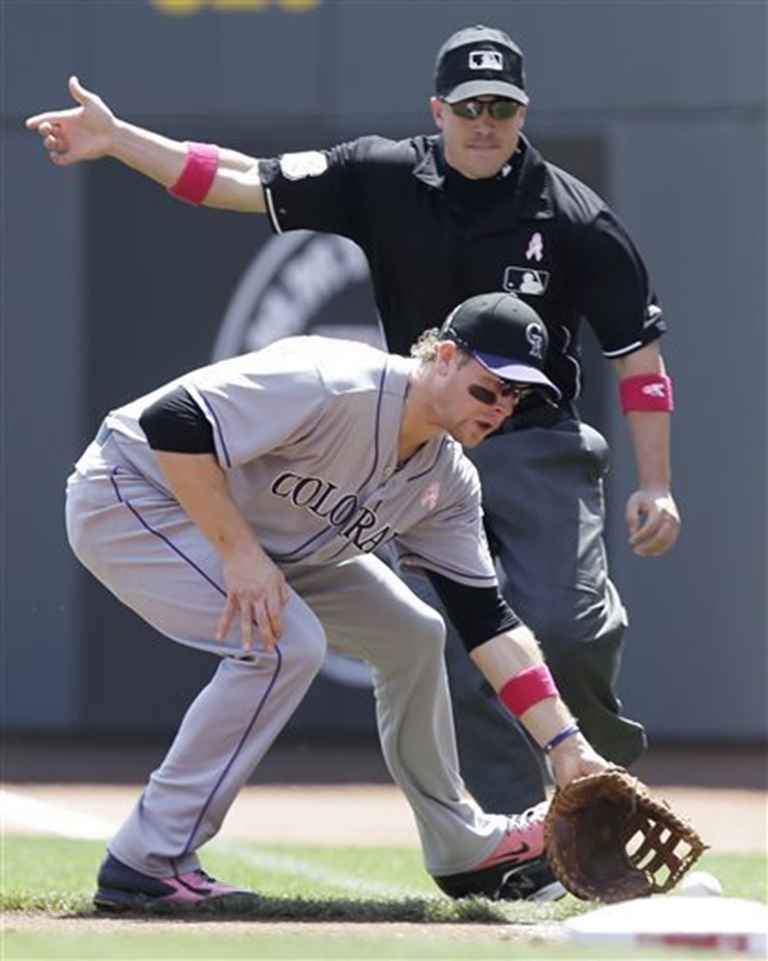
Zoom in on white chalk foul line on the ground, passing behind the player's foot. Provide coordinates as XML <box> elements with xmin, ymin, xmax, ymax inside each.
<box><xmin>0</xmin><ymin>788</ymin><xmax>424</xmax><ymax>898</ymax></box>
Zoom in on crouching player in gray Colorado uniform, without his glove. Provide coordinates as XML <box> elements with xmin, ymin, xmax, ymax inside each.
<box><xmin>66</xmin><ymin>293</ymin><xmax>606</xmax><ymax>911</ymax></box>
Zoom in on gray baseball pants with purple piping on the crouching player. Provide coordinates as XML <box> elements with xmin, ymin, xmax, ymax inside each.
<box><xmin>66</xmin><ymin>438</ymin><xmax>507</xmax><ymax>877</ymax></box>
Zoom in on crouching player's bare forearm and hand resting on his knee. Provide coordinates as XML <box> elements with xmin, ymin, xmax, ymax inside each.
<box><xmin>154</xmin><ymin>451</ymin><xmax>288</xmax><ymax>651</ymax></box>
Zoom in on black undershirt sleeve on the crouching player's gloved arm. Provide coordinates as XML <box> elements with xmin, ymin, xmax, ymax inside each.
<box><xmin>426</xmin><ymin>571</ymin><xmax>522</xmax><ymax>651</ymax></box>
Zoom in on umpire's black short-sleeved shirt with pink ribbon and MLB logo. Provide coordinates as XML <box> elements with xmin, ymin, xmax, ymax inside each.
<box><xmin>259</xmin><ymin>136</ymin><xmax>664</xmax><ymax>399</ymax></box>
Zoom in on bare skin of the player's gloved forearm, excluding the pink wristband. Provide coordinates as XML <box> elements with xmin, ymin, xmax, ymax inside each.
<box><xmin>470</xmin><ymin>625</ymin><xmax>608</xmax><ymax>784</ymax></box>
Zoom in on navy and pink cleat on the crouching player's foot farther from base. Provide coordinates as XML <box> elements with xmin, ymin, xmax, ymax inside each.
<box><xmin>93</xmin><ymin>854</ymin><xmax>259</xmax><ymax>912</ymax></box>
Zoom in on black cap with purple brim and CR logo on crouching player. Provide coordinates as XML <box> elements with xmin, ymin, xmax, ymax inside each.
<box><xmin>439</xmin><ymin>293</ymin><xmax>561</xmax><ymax>400</ymax></box>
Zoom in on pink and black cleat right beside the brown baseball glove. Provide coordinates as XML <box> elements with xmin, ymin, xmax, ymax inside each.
<box><xmin>434</xmin><ymin>801</ymin><xmax>565</xmax><ymax>901</ymax></box>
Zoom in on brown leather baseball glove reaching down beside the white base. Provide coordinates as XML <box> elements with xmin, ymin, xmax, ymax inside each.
<box><xmin>544</xmin><ymin>767</ymin><xmax>708</xmax><ymax>902</ymax></box>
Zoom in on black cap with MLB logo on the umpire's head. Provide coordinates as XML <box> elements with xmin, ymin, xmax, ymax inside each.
<box><xmin>435</xmin><ymin>24</ymin><xmax>528</xmax><ymax>103</ymax></box>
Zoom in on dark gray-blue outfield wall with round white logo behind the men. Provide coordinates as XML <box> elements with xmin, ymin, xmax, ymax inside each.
<box><xmin>0</xmin><ymin>0</ymin><xmax>768</xmax><ymax>740</ymax></box>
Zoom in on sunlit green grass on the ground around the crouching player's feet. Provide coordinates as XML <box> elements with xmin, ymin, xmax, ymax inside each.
<box><xmin>0</xmin><ymin>836</ymin><xmax>768</xmax><ymax>961</ymax></box>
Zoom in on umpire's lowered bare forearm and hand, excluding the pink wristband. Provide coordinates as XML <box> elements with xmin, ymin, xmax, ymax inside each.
<box><xmin>614</xmin><ymin>341</ymin><xmax>680</xmax><ymax>556</ymax></box>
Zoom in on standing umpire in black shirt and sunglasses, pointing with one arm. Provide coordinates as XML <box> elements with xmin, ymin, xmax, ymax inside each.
<box><xmin>27</xmin><ymin>26</ymin><xmax>680</xmax><ymax>898</ymax></box>
